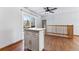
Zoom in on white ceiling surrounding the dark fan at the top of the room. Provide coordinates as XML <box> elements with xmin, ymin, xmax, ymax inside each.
<box><xmin>27</xmin><ymin>7</ymin><xmax>79</xmax><ymax>16</ymax></box>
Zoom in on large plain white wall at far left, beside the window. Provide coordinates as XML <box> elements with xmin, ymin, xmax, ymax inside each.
<box><xmin>0</xmin><ymin>7</ymin><xmax>23</xmax><ymax>48</ymax></box>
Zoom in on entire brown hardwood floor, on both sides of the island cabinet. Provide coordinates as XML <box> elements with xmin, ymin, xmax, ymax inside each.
<box><xmin>0</xmin><ymin>35</ymin><xmax>79</xmax><ymax>51</ymax></box>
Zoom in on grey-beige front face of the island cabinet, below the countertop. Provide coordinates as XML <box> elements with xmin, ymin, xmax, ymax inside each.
<box><xmin>24</xmin><ymin>31</ymin><xmax>39</xmax><ymax>51</ymax></box>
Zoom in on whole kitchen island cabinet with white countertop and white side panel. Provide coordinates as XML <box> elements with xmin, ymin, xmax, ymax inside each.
<box><xmin>24</xmin><ymin>28</ymin><xmax>45</xmax><ymax>51</ymax></box>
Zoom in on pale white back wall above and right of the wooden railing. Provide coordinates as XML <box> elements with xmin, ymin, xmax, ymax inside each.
<box><xmin>45</xmin><ymin>8</ymin><xmax>79</xmax><ymax>35</ymax></box>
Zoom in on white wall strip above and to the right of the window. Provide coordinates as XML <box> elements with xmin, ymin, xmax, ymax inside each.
<box><xmin>22</xmin><ymin>8</ymin><xmax>42</xmax><ymax>28</ymax></box>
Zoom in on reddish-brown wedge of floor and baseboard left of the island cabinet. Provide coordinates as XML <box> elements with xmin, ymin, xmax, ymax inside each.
<box><xmin>0</xmin><ymin>40</ymin><xmax>23</xmax><ymax>51</ymax></box>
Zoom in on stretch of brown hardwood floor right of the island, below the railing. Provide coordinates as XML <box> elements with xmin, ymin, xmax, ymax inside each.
<box><xmin>45</xmin><ymin>35</ymin><xmax>79</xmax><ymax>51</ymax></box>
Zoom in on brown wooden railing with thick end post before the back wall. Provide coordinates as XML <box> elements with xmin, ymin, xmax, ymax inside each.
<box><xmin>47</xmin><ymin>25</ymin><xmax>73</xmax><ymax>38</ymax></box>
